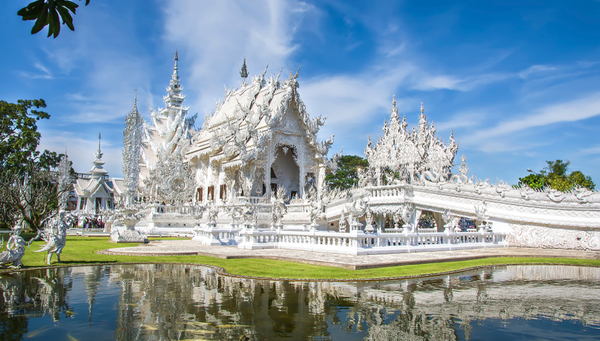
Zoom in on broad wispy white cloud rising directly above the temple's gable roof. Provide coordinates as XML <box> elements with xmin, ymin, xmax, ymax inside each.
<box><xmin>163</xmin><ymin>0</ymin><xmax>312</xmax><ymax>116</ymax></box>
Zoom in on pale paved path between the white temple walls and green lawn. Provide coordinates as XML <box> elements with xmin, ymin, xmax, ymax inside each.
<box><xmin>100</xmin><ymin>240</ymin><xmax>600</xmax><ymax>270</ymax></box>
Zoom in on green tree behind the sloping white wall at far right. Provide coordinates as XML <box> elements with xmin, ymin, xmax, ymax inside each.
<box><xmin>519</xmin><ymin>160</ymin><xmax>596</xmax><ymax>192</ymax></box>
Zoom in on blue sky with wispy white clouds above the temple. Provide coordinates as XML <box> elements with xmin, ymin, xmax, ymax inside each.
<box><xmin>0</xmin><ymin>0</ymin><xmax>600</xmax><ymax>184</ymax></box>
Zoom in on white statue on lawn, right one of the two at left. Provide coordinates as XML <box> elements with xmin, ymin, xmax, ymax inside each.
<box><xmin>27</xmin><ymin>210</ymin><xmax>75</xmax><ymax>265</ymax></box>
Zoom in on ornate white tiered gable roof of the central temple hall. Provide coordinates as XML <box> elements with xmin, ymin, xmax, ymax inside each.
<box><xmin>187</xmin><ymin>70</ymin><xmax>333</xmax><ymax>165</ymax></box>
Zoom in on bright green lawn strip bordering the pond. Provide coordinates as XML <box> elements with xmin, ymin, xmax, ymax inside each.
<box><xmin>4</xmin><ymin>236</ymin><xmax>600</xmax><ymax>280</ymax></box>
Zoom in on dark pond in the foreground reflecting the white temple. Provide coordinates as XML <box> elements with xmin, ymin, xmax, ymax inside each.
<box><xmin>0</xmin><ymin>264</ymin><xmax>600</xmax><ymax>341</ymax></box>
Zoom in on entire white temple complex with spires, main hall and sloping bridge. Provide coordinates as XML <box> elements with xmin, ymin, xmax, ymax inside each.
<box><xmin>102</xmin><ymin>53</ymin><xmax>600</xmax><ymax>254</ymax></box>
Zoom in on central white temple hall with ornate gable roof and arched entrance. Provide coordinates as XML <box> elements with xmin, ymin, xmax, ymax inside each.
<box><xmin>185</xmin><ymin>66</ymin><xmax>333</xmax><ymax>203</ymax></box>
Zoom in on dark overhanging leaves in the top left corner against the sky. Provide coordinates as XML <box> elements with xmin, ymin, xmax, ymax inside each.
<box><xmin>17</xmin><ymin>0</ymin><xmax>90</xmax><ymax>38</ymax></box>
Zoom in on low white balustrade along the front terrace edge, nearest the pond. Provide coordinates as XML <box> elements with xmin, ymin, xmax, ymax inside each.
<box><xmin>238</xmin><ymin>229</ymin><xmax>506</xmax><ymax>255</ymax></box>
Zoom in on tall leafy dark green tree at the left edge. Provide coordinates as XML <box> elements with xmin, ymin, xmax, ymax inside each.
<box><xmin>0</xmin><ymin>99</ymin><xmax>70</xmax><ymax>229</ymax></box>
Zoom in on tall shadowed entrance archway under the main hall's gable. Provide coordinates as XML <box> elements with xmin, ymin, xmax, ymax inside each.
<box><xmin>270</xmin><ymin>145</ymin><xmax>300</xmax><ymax>198</ymax></box>
